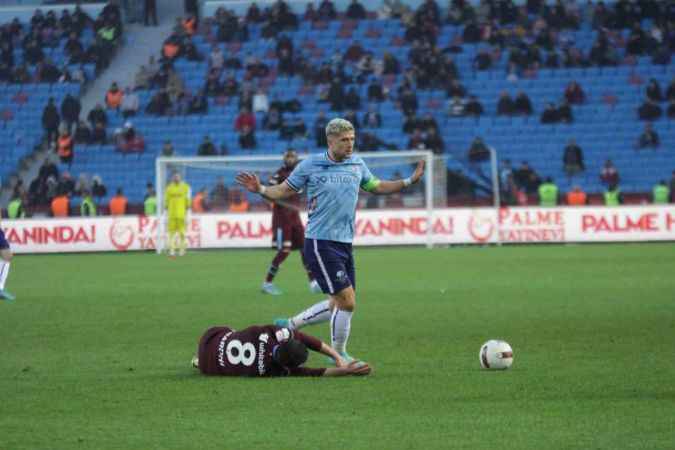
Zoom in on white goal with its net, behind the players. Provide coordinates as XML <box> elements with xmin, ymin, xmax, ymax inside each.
<box><xmin>155</xmin><ymin>151</ymin><xmax>436</xmax><ymax>253</ymax></box>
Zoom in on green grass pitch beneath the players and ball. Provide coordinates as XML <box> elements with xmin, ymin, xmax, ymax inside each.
<box><xmin>0</xmin><ymin>244</ymin><xmax>675</xmax><ymax>450</ymax></box>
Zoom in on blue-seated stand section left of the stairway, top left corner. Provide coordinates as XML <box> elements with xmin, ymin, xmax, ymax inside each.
<box><xmin>0</xmin><ymin>5</ymin><xmax>122</xmax><ymax>209</ymax></box>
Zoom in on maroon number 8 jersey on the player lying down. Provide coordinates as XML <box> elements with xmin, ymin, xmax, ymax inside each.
<box><xmin>198</xmin><ymin>325</ymin><xmax>326</xmax><ymax>377</ymax></box>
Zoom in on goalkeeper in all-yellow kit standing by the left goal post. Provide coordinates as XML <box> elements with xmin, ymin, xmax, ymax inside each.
<box><xmin>164</xmin><ymin>172</ymin><xmax>190</xmax><ymax>257</ymax></box>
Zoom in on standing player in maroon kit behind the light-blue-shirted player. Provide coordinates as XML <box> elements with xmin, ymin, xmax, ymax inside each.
<box><xmin>262</xmin><ymin>150</ymin><xmax>321</xmax><ymax>295</ymax></box>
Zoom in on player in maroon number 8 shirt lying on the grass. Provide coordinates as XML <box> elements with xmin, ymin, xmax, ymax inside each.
<box><xmin>192</xmin><ymin>325</ymin><xmax>370</xmax><ymax>377</ymax></box>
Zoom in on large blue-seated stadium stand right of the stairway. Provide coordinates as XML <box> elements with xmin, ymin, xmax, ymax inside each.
<box><xmin>6</xmin><ymin>0</ymin><xmax>675</xmax><ymax>210</ymax></box>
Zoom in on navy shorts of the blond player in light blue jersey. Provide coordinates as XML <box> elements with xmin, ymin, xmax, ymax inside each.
<box><xmin>304</xmin><ymin>239</ymin><xmax>356</xmax><ymax>294</ymax></box>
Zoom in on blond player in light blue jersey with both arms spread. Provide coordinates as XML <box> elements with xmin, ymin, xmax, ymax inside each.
<box><xmin>236</xmin><ymin>119</ymin><xmax>424</xmax><ymax>362</ymax></box>
